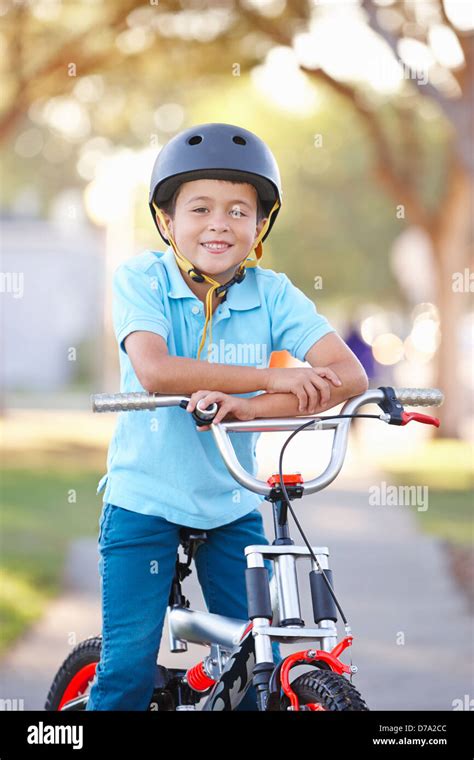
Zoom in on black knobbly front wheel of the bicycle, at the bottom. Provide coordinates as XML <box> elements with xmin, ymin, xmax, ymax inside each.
<box><xmin>280</xmin><ymin>670</ymin><xmax>369</xmax><ymax>712</ymax></box>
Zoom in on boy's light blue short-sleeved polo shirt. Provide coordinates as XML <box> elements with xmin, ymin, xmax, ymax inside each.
<box><xmin>97</xmin><ymin>246</ymin><xmax>335</xmax><ymax>529</ymax></box>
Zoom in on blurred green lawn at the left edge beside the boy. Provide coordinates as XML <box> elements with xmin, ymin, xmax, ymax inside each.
<box><xmin>0</xmin><ymin>460</ymin><xmax>102</xmax><ymax>655</ymax></box>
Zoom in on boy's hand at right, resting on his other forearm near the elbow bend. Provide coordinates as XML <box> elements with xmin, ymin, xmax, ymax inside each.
<box><xmin>266</xmin><ymin>367</ymin><xmax>342</xmax><ymax>414</ymax></box>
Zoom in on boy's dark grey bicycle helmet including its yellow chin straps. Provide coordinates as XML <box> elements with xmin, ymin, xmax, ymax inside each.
<box><xmin>149</xmin><ymin>123</ymin><xmax>282</xmax><ymax>359</ymax></box>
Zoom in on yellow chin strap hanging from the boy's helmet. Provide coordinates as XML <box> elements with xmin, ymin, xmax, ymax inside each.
<box><xmin>153</xmin><ymin>198</ymin><xmax>280</xmax><ymax>359</ymax></box>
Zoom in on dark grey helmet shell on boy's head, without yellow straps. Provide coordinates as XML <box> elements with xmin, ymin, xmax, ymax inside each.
<box><xmin>149</xmin><ymin>123</ymin><xmax>282</xmax><ymax>244</ymax></box>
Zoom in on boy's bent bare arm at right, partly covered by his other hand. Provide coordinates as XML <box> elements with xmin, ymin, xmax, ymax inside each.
<box><xmin>246</xmin><ymin>333</ymin><xmax>369</xmax><ymax>418</ymax></box>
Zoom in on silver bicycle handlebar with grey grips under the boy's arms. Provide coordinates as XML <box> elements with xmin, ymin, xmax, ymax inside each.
<box><xmin>91</xmin><ymin>388</ymin><xmax>444</xmax><ymax>496</ymax></box>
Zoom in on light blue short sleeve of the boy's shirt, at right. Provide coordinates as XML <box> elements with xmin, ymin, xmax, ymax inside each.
<box><xmin>270</xmin><ymin>273</ymin><xmax>336</xmax><ymax>362</ymax></box>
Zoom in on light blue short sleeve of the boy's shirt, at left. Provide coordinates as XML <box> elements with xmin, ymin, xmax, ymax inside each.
<box><xmin>112</xmin><ymin>264</ymin><xmax>171</xmax><ymax>351</ymax></box>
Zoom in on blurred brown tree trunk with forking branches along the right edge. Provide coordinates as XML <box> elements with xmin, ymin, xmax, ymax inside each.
<box><xmin>250</xmin><ymin>0</ymin><xmax>474</xmax><ymax>437</ymax></box>
